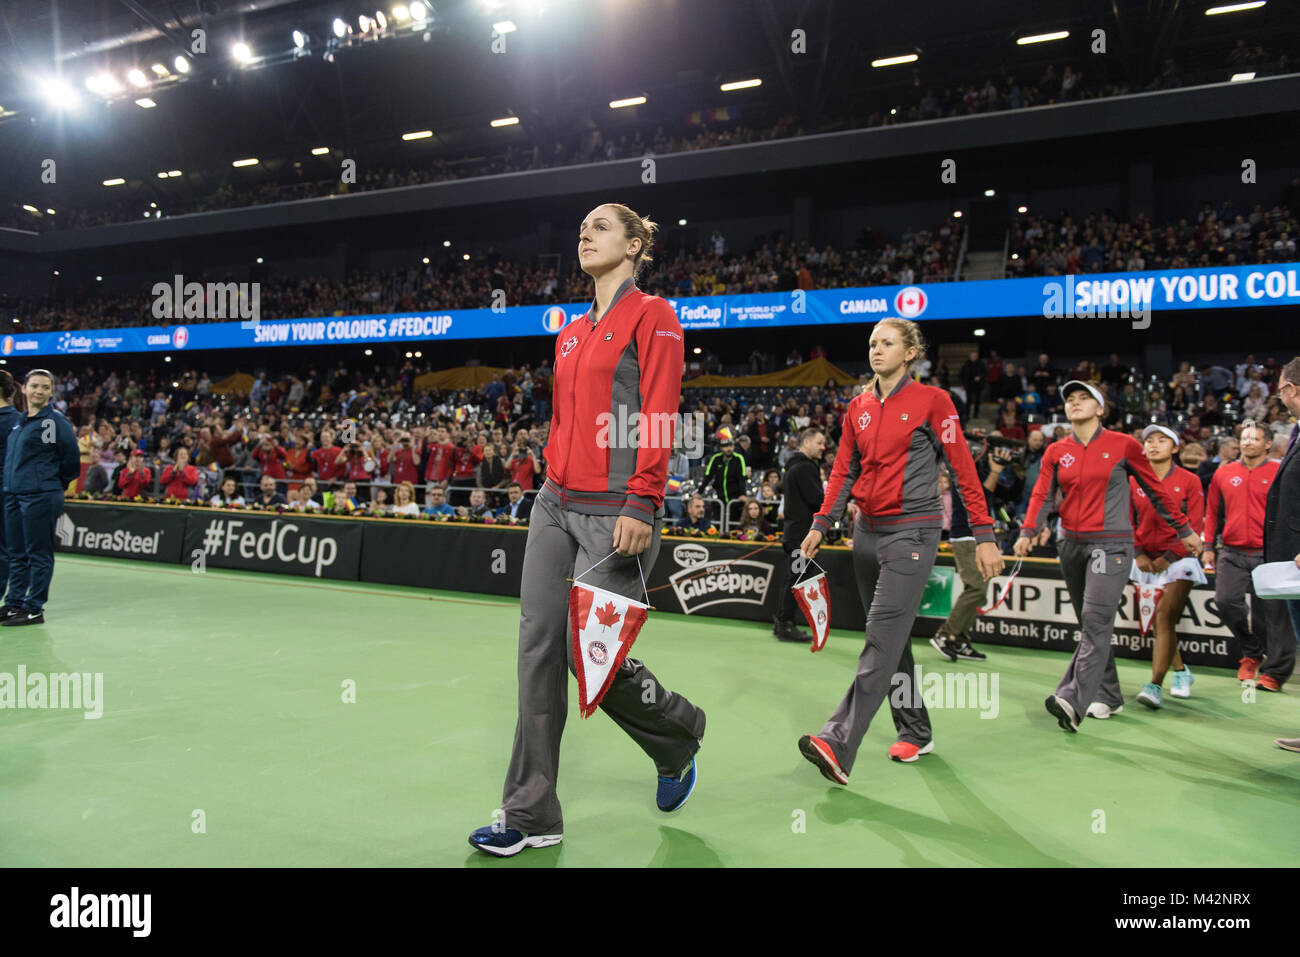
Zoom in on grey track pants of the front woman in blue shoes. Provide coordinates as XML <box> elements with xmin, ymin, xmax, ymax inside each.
<box><xmin>501</xmin><ymin>492</ymin><xmax>705</xmax><ymax>833</ymax></box>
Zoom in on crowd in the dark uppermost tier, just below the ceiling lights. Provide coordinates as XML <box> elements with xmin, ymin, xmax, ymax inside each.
<box><xmin>0</xmin><ymin>39</ymin><xmax>1292</xmax><ymax>231</ymax></box>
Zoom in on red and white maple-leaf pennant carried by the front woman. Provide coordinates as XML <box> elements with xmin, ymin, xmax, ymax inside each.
<box><xmin>569</xmin><ymin>583</ymin><xmax>650</xmax><ymax>718</ymax></box>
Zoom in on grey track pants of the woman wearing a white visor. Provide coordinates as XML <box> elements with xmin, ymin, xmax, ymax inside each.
<box><xmin>1056</xmin><ymin>538</ymin><xmax>1134</xmax><ymax>722</ymax></box>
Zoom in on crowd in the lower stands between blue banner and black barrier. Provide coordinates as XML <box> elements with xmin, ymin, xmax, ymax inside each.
<box><xmin>35</xmin><ymin>350</ymin><xmax>1292</xmax><ymax>553</ymax></box>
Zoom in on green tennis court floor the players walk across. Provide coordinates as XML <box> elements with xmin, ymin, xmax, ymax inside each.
<box><xmin>0</xmin><ymin>557</ymin><xmax>1300</xmax><ymax>867</ymax></box>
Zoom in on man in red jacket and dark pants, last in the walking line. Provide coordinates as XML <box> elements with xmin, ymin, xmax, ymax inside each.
<box><xmin>1204</xmin><ymin>423</ymin><xmax>1296</xmax><ymax>692</ymax></box>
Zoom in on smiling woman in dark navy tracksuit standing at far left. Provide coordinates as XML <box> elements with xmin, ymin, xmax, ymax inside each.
<box><xmin>3</xmin><ymin>369</ymin><xmax>81</xmax><ymax>627</ymax></box>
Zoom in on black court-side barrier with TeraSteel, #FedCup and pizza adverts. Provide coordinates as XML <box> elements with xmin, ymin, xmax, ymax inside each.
<box><xmin>57</xmin><ymin>502</ymin><xmax>1238</xmax><ymax>668</ymax></box>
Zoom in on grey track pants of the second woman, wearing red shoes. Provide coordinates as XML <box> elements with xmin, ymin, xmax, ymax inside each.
<box><xmin>818</xmin><ymin>524</ymin><xmax>940</xmax><ymax>774</ymax></box>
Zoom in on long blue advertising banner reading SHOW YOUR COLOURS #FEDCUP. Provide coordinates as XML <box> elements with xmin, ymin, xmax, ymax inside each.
<box><xmin>0</xmin><ymin>263</ymin><xmax>1300</xmax><ymax>356</ymax></box>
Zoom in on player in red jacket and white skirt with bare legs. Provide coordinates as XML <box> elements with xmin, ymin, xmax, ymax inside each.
<box><xmin>1133</xmin><ymin>425</ymin><xmax>1205</xmax><ymax>718</ymax></box>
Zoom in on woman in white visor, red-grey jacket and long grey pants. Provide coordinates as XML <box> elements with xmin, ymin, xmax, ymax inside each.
<box><xmin>1015</xmin><ymin>380</ymin><xmax>1201</xmax><ymax>733</ymax></box>
